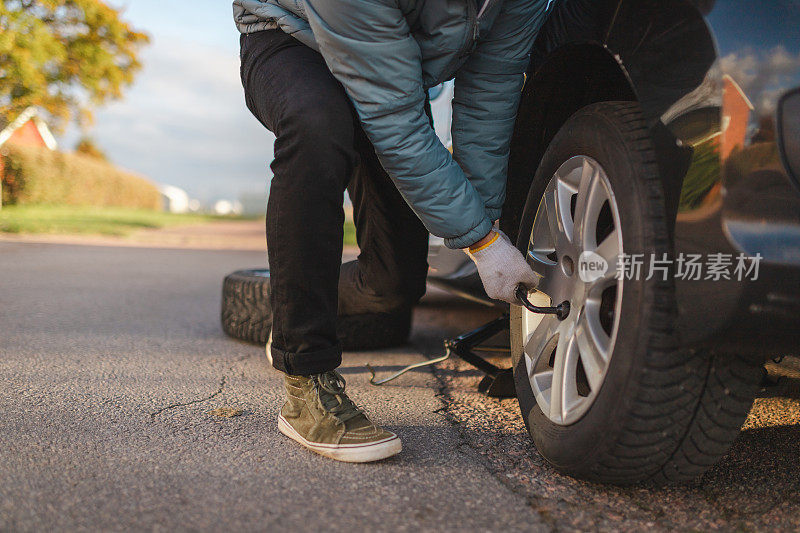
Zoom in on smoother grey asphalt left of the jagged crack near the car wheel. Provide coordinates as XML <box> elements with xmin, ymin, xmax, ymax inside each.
<box><xmin>0</xmin><ymin>243</ymin><xmax>546</xmax><ymax>531</ymax></box>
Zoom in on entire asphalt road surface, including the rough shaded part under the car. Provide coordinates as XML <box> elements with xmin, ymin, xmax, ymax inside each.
<box><xmin>0</xmin><ymin>243</ymin><xmax>800</xmax><ymax>531</ymax></box>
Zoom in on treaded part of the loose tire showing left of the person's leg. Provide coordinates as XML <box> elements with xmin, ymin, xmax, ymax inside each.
<box><xmin>222</xmin><ymin>269</ymin><xmax>272</xmax><ymax>345</ymax></box>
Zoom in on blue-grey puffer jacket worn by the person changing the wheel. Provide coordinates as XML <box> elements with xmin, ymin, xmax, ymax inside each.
<box><xmin>233</xmin><ymin>0</ymin><xmax>553</xmax><ymax>248</ymax></box>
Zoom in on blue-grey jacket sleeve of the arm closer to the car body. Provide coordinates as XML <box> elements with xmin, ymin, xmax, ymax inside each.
<box><xmin>452</xmin><ymin>0</ymin><xmax>552</xmax><ymax>220</ymax></box>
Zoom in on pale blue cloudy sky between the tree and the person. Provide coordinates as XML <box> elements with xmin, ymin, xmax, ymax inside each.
<box><xmin>60</xmin><ymin>0</ymin><xmax>274</xmax><ymax>202</ymax></box>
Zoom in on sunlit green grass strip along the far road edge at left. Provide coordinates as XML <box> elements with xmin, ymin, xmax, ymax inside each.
<box><xmin>0</xmin><ymin>205</ymin><xmax>250</xmax><ymax>236</ymax></box>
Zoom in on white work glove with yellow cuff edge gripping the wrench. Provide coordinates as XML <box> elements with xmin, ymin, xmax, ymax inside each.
<box><xmin>467</xmin><ymin>229</ymin><xmax>539</xmax><ymax>305</ymax></box>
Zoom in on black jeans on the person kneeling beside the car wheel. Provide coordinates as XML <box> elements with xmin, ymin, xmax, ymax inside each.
<box><xmin>241</xmin><ymin>30</ymin><xmax>428</xmax><ymax>375</ymax></box>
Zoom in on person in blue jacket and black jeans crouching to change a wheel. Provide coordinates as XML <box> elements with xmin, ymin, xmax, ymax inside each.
<box><xmin>233</xmin><ymin>0</ymin><xmax>552</xmax><ymax>462</ymax></box>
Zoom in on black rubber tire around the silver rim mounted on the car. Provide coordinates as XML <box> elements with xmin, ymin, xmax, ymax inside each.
<box><xmin>511</xmin><ymin>102</ymin><xmax>760</xmax><ymax>484</ymax></box>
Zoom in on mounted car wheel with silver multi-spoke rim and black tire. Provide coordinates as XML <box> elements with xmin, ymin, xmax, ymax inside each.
<box><xmin>511</xmin><ymin>102</ymin><xmax>760</xmax><ymax>484</ymax></box>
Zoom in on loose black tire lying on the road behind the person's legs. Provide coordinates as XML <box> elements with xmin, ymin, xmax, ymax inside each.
<box><xmin>221</xmin><ymin>269</ymin><xmax>412</xmax><ymax>351</ymax></box>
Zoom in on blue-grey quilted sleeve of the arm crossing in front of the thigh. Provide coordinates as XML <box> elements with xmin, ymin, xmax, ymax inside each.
<box><xmin>305</xmin><ymin>0</ymin><xmax>492</xmax><ymax>248</ymax></box>
